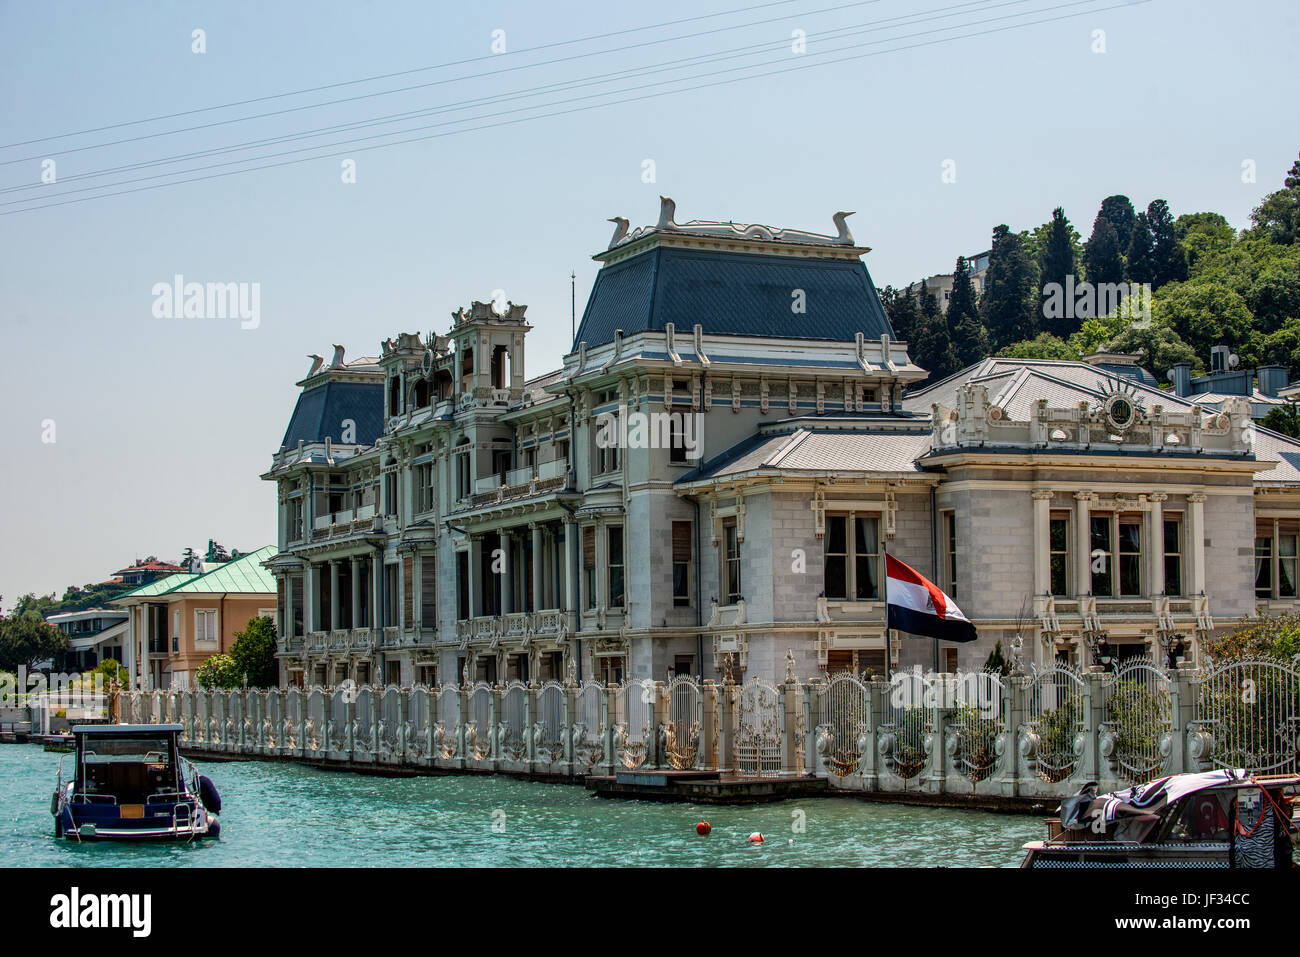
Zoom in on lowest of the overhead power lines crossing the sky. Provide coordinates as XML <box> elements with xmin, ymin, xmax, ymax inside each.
<box><xmin>0</xmin><ymin>0</ymin><xmax>1151</xmax><ymax>216</ymax></box>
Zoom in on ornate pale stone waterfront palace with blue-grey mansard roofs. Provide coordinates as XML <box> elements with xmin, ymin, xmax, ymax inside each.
<box><xmin>264</xmin><ymin>199</ymin><xmax>1300</xmax><ymax>684</ymax></box>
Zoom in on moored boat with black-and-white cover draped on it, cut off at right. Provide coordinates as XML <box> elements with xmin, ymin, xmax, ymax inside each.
<box><xmin>1021</xmin><ymin>768</ymin><xmax>1300</xmax><ymax>867</ymax></box>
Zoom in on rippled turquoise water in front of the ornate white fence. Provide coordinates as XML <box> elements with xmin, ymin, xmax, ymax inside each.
<box><xmin>0</xmin><ymin>745</ymin><xmax>1043</xmax><ymax>867</ymax></box>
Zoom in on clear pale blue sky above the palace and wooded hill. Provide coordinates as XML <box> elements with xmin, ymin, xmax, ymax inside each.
<box><xmin>0</xmin><ymin>0</ymin><xmax>1300</xmax><ymax>600</ymax></box>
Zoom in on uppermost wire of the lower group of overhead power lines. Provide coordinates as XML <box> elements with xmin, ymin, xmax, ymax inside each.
<box><xmin>0</xmin><ymin>0</ymin><xmax>1008</xmax><ymax>195</ymax></box>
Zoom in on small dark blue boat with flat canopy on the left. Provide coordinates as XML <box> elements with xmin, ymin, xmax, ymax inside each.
<box><xmin>49</xmin><ymin>724</ymin><xmax>221</xmax><ymax>841</ymax></box>
